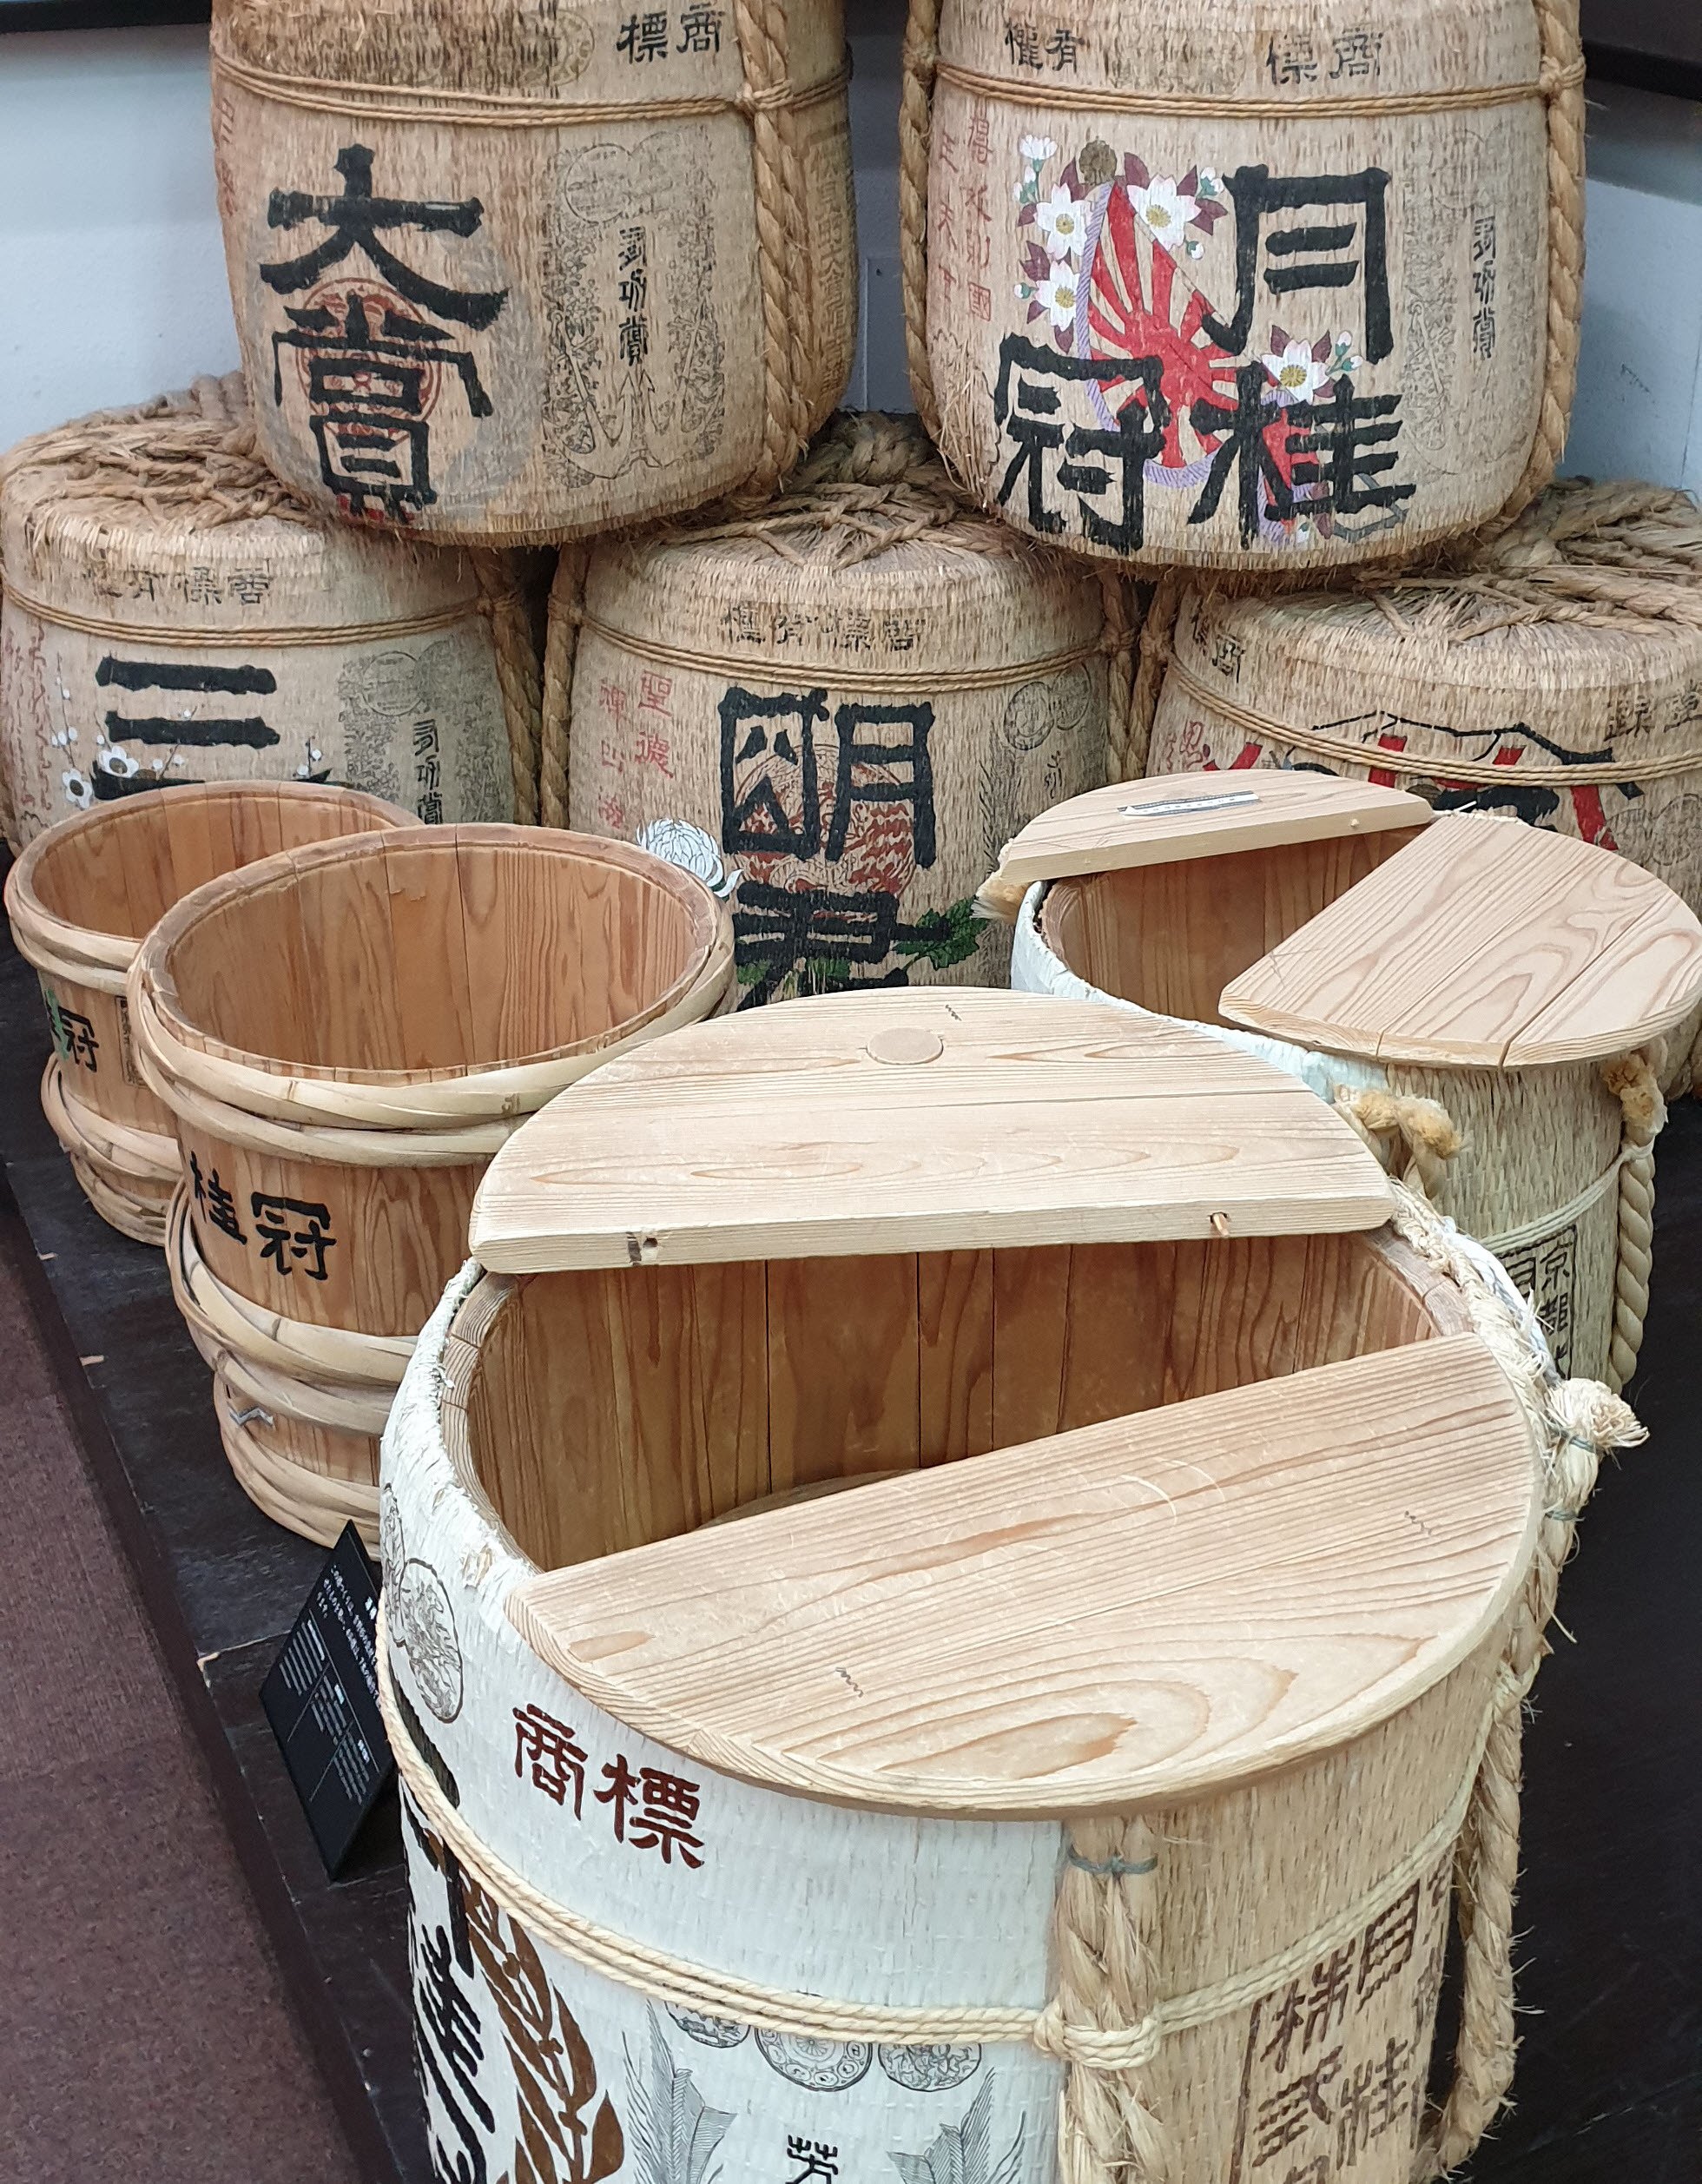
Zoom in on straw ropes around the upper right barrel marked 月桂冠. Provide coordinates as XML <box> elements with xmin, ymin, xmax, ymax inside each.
<box><xmin>898</xmin><ymin>0</ymin><xmax>1584</xmax><ymax>532</ymax></box>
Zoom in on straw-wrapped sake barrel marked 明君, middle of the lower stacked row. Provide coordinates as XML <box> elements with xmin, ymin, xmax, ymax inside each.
<box><xmin>544</xmin><ymin>415</ymin><xmax>1130</xmax><ymax>1005</ymax></box>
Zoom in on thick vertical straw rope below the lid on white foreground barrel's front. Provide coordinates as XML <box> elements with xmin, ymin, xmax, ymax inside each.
<box><xmin>1033</xmin><ymin>1817</ymin><xmax>1169</xmax><ymax>2184</ymax></box>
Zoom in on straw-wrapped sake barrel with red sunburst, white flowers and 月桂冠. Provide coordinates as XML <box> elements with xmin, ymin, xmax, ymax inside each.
<box><xmin>900</xmin><ymin>0</ymin><xmax>1584</xmax><ymax>577</ymax></box>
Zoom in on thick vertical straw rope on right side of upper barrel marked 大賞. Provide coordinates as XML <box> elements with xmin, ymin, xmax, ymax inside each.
<box><xmin>734</xmin><ymin>0</ymin><xmax>810</xmax><ymax>493</ymax></box>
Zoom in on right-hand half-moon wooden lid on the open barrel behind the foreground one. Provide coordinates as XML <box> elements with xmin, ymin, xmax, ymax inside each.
<box><xmin>1221</xmin><ymin>813</ymin><xmax>1702</xmax><ymax>1070</ymax></box>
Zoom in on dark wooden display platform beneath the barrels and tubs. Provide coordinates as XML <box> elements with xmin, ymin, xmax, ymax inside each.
<box><xmin>0</xmin><ymin>941</ymin><xmax>1702</xmax><ymax>2184</ymax></box>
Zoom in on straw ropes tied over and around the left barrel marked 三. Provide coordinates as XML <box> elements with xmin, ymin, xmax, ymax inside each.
<box><xmin>0</xmin><ymin>372</ymin><xmax>539</xmax><ymax>821</ymax></box>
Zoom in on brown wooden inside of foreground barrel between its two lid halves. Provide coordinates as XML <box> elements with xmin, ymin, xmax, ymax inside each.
<box><xmin>444</xmin><ymin>1231</ymin><xmax>1464</xmax><ymax>1568</ymax></box>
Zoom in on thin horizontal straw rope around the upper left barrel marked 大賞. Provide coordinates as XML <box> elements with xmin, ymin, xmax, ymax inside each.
<box><xmin>212</xmin><ymin>37</ymin><xmax>850</xmax><ymax>129</ymax></box>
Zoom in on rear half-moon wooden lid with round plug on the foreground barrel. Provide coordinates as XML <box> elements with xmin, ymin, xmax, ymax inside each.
<box><xmin>470</xmin><ymin>987</ymin><xmax>1389</xmax><ymax>1273</ymax></box>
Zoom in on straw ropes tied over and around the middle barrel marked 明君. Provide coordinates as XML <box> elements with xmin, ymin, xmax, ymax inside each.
<box><xmin>539</xmin><ymin>411</ymin><xmax>1134</xmax><ymax>826</ymax></box>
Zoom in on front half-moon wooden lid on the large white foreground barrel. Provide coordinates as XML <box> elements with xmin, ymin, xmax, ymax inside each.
<box><xmin>509</xmin><ymin>1335</ymin><xmax>1540</xmax><ymax>1817</ymax></box>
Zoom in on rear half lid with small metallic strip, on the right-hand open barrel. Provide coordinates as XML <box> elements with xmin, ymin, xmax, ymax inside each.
<box><xmin>987</xmin><ymin>767</ymin><xmax>1431</xmax><ymax>894</ymax></box>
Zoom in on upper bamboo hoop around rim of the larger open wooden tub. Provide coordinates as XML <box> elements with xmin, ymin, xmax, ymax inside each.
<box><xmin>127</xmin><ymin>908</ymin><xmax>732</xmax><ymax>1135</ymax></box>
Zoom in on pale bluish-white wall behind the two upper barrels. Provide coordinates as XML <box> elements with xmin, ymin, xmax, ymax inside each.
<box><xmin>0</xmin><ymin>27</ymin><xmax>1702</xmax><ymax>489</ymax></box>
